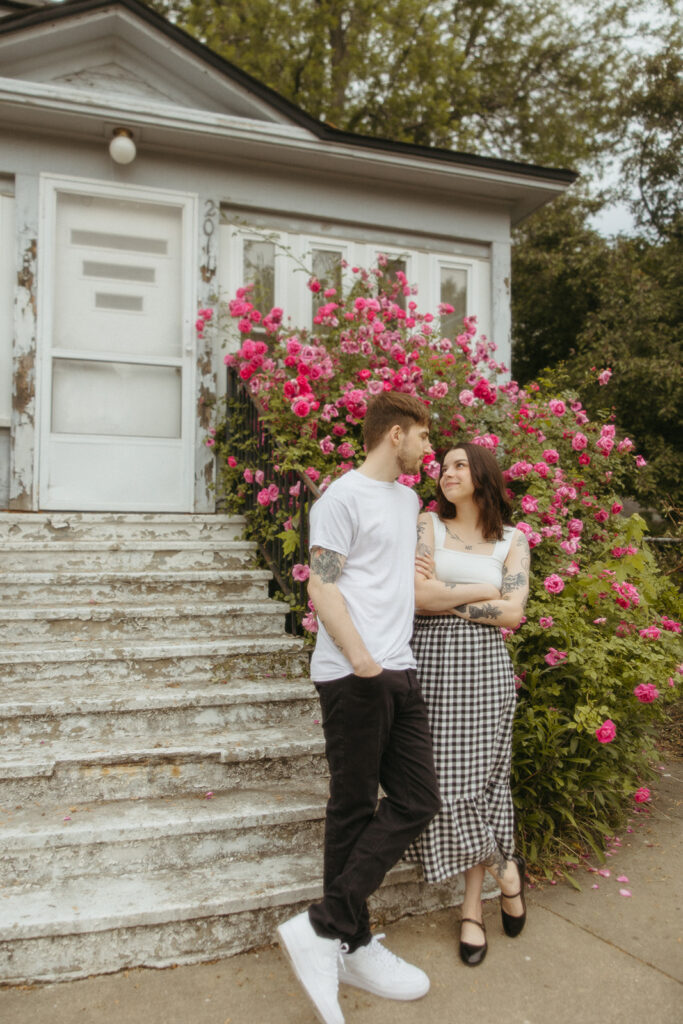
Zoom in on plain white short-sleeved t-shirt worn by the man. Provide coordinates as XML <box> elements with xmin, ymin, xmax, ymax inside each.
<box><xmin>309</xmin><ymin>469</ymin><xmax>420</xmax><ymax>683</ymax></box>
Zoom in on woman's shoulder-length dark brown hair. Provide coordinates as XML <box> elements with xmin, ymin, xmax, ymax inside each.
<box><xmin>436</xmin><ymin>441</ymin><xmax>512</xmax><ymax>541</ymax></box>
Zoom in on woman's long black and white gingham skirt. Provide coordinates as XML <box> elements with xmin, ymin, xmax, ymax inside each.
<box><xmin>404</xmin><ymin>615</ymin><xmax>516</xmax><ymax>882</ymax></box>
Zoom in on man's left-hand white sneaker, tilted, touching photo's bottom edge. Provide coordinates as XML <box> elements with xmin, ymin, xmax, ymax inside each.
<box><xmin>278</xmin><ymin>910</ymin><xmax>344</xmax><ymax>1024</ymax></box>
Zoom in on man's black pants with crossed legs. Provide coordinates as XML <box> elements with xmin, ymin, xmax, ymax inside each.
<box><xmin>308</xmin><ymin>669</ymin><xmax>441</xmax><ymax>952</ymax></box>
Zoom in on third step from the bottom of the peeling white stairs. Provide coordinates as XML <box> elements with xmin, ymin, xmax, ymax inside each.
<box><xmin>0</xmin><ymin>721</ymin><xmax>327</xmax><ymax>810</ymax></box>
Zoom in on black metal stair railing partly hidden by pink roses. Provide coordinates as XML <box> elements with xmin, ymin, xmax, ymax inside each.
<box><xmin>225</xmin><ymin>367</ymin><xmax>321</xmax><ymax>636</ymax></box>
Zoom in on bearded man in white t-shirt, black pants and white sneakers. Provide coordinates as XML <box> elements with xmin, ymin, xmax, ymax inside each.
<box><xmin>278</xmin><ymin>392</ymin><xmax>440</xmax><ymax>1024</ymax></box>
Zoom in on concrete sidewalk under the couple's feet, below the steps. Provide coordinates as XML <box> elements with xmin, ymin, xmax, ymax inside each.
<box><xmin>0</xmin><ymin>761</ymin><xmax>683</xmax><ymax>1024</ymax></box>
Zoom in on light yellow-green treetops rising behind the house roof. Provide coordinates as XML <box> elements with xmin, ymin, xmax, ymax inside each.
<box><xmin>144</xmin><ymin>0</ymin><xmax>669</xmax><ymax>166</ymax></box>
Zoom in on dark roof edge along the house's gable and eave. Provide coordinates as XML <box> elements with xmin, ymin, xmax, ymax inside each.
<box><xmin>0</xmin><ymin>0</ymin><xmax>578</xmax><ymax>190</ymax></box>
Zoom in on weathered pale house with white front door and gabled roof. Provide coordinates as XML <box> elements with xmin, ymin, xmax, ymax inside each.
<box><xmin>0</xmin><ymin>0</ymin><xmax>574</xmax><ymax>512</ymax></box>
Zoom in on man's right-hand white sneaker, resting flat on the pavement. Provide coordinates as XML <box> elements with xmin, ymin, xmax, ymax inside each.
<box><xmin>339</xmin><ymin>935</ymin><xmax>429</xmax><ymax>999</ymax></box>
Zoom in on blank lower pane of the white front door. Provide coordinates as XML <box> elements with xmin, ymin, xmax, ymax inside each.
<box><xmin>52</xmin><ymin>359</ymin><xmax>181</xmax><ymax>437</ymax></box>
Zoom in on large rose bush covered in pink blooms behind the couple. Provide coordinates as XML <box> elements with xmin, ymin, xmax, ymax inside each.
<box><xmin>208</xmin><ymin>260</ymin><xmax>683</xmax><ymax>869</ymax></box>
